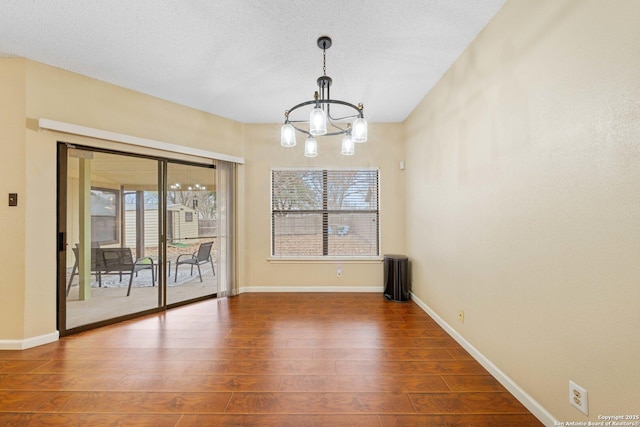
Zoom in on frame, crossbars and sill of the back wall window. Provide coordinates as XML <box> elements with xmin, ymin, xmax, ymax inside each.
<box><xmin>268</xmin><ymin>167</ymin><xmax>382</xmax><ymax>263</ymax></box>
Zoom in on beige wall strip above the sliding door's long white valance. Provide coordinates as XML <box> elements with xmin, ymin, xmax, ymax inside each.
<box><xmin>27</xmin><ymin>61</ymin><xmax>244</xmax><ymax>156</ymax></box>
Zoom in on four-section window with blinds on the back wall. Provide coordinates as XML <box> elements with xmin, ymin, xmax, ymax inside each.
<box><xmin>271</xmin><ymin>169</ymin><xmax>380</xmax><ymax>257</ymax></box>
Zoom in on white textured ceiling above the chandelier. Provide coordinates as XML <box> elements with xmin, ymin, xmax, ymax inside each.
<box><xmin>0</xmin><ymin>0</ymin><xmax>506</xmax><ymax>123</ymax></box>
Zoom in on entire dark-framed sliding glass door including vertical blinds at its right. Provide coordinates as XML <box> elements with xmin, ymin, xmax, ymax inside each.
<box><xmin>58</xmin><ymin>143</ymin><xmax>235</xmax><ymax>335</ymax></box>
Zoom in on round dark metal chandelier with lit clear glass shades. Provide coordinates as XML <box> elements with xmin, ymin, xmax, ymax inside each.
<box><xmin>280</xmin><ymin>36</ymin><xmax>367</xmax><ymax>157</ymax></box>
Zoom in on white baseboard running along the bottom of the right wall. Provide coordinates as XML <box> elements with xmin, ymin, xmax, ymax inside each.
<box><xmin>411</xmin><ymin>293</ymin><xmax>558</xmax><ymax>426</ymax></box>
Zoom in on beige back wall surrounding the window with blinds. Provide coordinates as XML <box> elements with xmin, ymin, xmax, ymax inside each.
<box><xmin>242</xmin><ymin>124</ymin><xmax>405</xmax><ymax>291</ymax></box>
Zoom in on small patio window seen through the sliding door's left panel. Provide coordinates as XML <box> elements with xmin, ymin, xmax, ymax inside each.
<box><xmin>91</xmin><ymin>187</ymin><xmax>120</xmax><ymax>244</ymax></box>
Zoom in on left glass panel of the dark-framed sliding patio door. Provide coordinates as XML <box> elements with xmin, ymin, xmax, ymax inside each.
<box><xmin>59</xmin><ymin>148</ymin><xmax>165</xmax><ymax>331</ymax></box>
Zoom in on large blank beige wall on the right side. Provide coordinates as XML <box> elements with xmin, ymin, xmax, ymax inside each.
<box><xmin>405</xmin><ymin>0</ymin><xmax>640</xmax><ymax>421</ymax></box>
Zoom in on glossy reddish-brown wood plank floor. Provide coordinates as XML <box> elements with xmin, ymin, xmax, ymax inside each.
<box><xmin>0</xmin><ymin>293</ymin><xmax>542</xmax><ymax>427</ymax></box>
